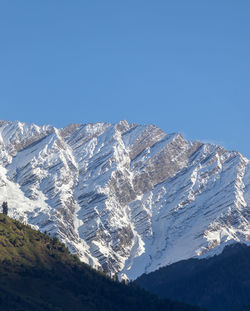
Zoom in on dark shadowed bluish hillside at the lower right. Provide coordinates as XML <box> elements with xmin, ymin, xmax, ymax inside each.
<box><xmin>135</xmin><ymin>244</ymin><xmax>250</xmax><ymax>311</ymax></box>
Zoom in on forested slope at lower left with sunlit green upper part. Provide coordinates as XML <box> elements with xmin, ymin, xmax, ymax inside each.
<box><xmin>0</xmin><ymin>214</ymin><xmax>203</xmax><ymax>311</ymax></box>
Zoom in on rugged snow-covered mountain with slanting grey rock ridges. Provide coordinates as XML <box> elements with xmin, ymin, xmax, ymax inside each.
<box><xmin>0</xmin><ymin>121</ymin><xmax>250</xmax><ymax>279</ymax></box>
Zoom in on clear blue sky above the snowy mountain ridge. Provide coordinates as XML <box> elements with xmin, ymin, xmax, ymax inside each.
<box><xmin>0</xmin><ymin>0</ymin><xmax>250</xmax><ymax>158</ymax></box>
